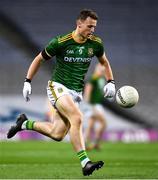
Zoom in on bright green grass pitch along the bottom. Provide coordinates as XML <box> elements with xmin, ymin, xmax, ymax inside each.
<box><xmin>0</xmin><ymin>141</ymin><xmax>158</xmax><ymax>179</ymax></box>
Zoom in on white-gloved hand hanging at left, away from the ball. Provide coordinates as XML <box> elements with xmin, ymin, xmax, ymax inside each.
<box><xmin>23</xmin><ymin>79</ymin><xmax>32</xmax><ymax>102</ymax></box>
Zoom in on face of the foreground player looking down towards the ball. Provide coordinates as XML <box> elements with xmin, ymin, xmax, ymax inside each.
<box><xmin>78</xmin><ymin>17</ymin><xmax>97</xmax><ymax>38</ymax></box>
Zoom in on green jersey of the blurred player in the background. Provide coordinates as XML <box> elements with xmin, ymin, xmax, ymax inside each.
<box><xmin>89</xmin><ymin>76</ymin><xmax>106</xmax><ymax>104</ymax></box>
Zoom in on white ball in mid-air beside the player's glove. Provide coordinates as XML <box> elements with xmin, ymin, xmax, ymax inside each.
<box><xmin>116</xmin><ymin>86</ymin><xmax>139</xmax><ymax>108</ymax></box>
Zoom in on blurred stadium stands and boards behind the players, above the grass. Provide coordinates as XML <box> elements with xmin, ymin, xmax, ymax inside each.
<box><xmin>0</xmin><ymin>0</ymin><xmax>158</xmax><ymax>141</ymax></box>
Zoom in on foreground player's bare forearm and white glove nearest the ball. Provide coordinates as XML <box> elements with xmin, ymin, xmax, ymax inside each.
<box><xmin>98</xmin><ymin>53</ymin><xmax>116</xmax><ymax>98</ymax></box>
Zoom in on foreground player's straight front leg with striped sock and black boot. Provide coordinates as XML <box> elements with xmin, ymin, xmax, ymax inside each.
<box><xmin>56</xmin><ymin>95</ymin><xmax>104</xmax><ymax>176</ymax></box>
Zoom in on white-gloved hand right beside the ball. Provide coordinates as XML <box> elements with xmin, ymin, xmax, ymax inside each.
<box><xmin>104</xmin><ymin>80</ymin><xmax>116</xmax><ymax>98</ymax></box>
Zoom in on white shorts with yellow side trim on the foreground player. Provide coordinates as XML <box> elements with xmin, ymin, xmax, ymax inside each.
<box><xmin>47</xmin><ymin>81</ymin><xmax>82</xmax><ymax>107</ymax></box>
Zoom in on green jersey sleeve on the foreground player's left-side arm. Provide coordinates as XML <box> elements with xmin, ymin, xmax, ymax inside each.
<box><xmin>45</xmin><ymin>38</ymin><xmax>59</xmax><ymax>58</ymax></box>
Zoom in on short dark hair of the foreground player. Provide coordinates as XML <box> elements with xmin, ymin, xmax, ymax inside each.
<box><xmin>77</xmin><ymin>9</ymin><xmax>98</xmax><ymax>21</ymax></box>
